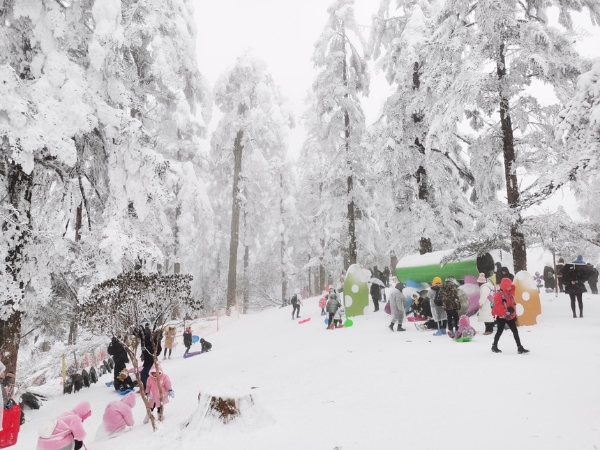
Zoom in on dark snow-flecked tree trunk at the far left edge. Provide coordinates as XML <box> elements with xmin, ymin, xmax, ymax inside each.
<box><xmin>0</xmin><ymin>160</ymin><xmax>33</xmax><ymax>374</ymax></box>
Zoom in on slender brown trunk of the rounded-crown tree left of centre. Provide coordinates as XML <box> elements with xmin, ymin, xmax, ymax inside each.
<box><xmin>227</xmin><ymin>111</ymin><xmax>244</xmax><ymax>311</ymax></box>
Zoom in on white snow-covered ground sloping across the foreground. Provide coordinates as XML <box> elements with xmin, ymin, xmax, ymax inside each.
<box><xmin>16</xmin><ymin>293</ymin><xmax>600</xmax><ymax>450</ymax></box>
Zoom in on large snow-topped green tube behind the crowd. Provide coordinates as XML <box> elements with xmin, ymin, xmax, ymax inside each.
<box><xmin>396</xmin><ymin>250</ymin><xmax>494</xmax><ymax>283</ymax></box>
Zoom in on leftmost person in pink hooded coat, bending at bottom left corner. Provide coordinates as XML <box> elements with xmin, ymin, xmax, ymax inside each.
<box><xmin>37</xmin><ymin>401</ymin><xmax>92</xmax><ymax>450</ymax></box>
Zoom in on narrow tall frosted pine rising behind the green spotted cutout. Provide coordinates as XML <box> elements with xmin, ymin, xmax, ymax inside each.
<box><xmin>302</xmin><ymin>0</ymin><xmax>377</xmax><ymax>270</ymax></box>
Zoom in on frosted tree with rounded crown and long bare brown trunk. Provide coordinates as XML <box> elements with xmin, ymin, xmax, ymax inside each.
<box><xmin>212</xmin><ymin>52</ymin><xmax>293</xmax><ymax>310</ymax></box>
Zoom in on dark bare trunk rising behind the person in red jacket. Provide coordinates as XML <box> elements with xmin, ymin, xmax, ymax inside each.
<box><xmin>496</xmin><ymin>44</ymin><xmax>527</xmax><ymax>273</ymax></box>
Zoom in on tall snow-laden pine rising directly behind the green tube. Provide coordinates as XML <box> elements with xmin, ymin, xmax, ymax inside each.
<box><xmin>365</xmin><ymin>0</ymin><xmax>476</xmax><ymax>253</ymax></box>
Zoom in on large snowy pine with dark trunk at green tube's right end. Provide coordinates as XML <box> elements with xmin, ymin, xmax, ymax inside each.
<box><xmin>423</xmin><ymin>0</ymin><xmax>596</xmax><ymax>271</ymax></box>
